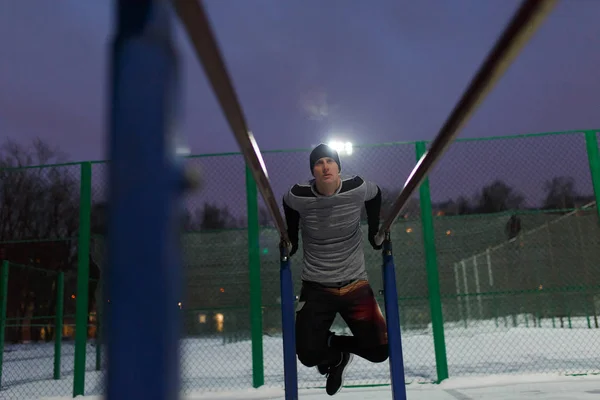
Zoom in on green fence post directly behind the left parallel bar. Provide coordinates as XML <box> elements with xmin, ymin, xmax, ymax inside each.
<box><xmin>246</xmin><ymin>166</ymin><xmax>265</xmax><ymax>388</ymax></box>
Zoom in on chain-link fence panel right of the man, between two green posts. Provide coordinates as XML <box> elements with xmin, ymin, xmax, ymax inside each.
<box><xmin>430</xmin><ymin>133</ymin><xmax>600</xmax><ymax>376</ymax></box>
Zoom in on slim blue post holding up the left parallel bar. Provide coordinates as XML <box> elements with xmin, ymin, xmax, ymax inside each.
<box><xmin>279</xmin><ymin>242</ymin><xmax>298</xmax><ymax>400</ymax></box>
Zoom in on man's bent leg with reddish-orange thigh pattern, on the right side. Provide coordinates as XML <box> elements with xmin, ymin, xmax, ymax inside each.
<box><xmin>331</xmin><ymin>280</ymin><xmax>389</xmax><ymax>363</ymax></box>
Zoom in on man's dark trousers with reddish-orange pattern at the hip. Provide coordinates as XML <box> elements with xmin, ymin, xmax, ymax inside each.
<box><xmin>296</xmin><ymin>280</ymin><xmax>388</xmax><ymax>367</ymax></box>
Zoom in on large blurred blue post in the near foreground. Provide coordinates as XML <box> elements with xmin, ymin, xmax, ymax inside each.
<box><xmin>104</xmin><ymin>0</ymin><xmax>185</xmax><ymax>400</ymax></box>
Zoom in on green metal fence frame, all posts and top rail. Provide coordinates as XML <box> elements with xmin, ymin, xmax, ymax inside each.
<box><xmin>0</xmin><ymin>130</ymin><xmax>600</xmax><ymax>397</ymax></box>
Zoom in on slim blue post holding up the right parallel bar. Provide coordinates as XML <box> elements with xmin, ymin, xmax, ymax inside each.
<box><xmin>382</xmin><ymin>232</ymin><xmax>406</xmax><ymax>400</ymax></box>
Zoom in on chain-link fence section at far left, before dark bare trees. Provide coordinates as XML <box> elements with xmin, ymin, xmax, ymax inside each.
<box><xmin>0</xmin><ymin>162</ymin><xmax>98</xmax><ymax>399</ymax></box>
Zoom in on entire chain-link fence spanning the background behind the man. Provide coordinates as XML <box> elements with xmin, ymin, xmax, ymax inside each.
<box><xmin>0</xmin><ymin>132</ymin><xmax>600</xmax><ymax>398</ymax></box>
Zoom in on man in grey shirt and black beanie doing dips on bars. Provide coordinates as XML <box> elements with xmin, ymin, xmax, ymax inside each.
<box><xmin>283</xmin><ymin>144</ymin><xmax>388</xmax><ymax>396</ymax></box>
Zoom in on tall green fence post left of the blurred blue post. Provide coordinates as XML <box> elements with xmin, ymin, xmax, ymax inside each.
<box><xmin>73</xmin><ymin>162</ymin><xmax>92</xmax><ymax>397</ymax></box>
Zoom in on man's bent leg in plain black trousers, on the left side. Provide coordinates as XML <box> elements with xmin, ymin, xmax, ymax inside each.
<box><xmin>296</xmin><ymin>282</ymin><xmax>341</xmax><ymax>367</ymax></box>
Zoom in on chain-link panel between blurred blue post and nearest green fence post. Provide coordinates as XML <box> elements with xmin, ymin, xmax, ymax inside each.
<box><xmin>179</xmin><ymin>154</ymin><xmax>252</xmax><ymax>392</ymax></box>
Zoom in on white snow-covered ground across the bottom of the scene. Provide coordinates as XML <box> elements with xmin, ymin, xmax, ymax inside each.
<box><xmin>0</xmin><ymin>318</ymin><xmax>600</xmax><ymax>400</ymax></box>
